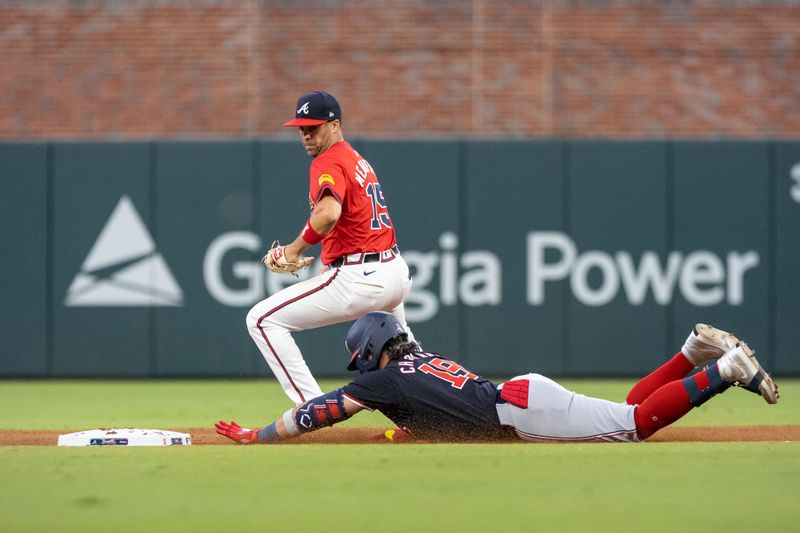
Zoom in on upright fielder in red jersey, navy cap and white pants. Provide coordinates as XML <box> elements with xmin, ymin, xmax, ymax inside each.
<box><xmin>247</xmin><ymin>91</ymin><xmax>411</xmax><ymax>404</ymax></box>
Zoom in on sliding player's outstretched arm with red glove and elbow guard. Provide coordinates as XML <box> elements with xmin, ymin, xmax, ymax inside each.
<box><xmin>215</xmin><ymin>389</ymin><xmax>364</xmax><ymax>444</ymax></box>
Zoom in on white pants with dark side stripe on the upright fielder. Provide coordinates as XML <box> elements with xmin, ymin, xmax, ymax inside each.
<box><xmin>247</xmin><ymin>252</ymin><xmax>413</xmax><ymax>404</ymax></box>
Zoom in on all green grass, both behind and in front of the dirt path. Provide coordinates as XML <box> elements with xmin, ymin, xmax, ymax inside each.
<box><xmin>0</xmin><ymin>380</ymin><xmax>800</xmax><ymax>532</ymax></box>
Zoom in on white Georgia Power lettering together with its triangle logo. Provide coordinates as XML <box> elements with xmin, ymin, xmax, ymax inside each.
<box><xmin>65</xmin><ymin>196</ymin><xmax>760</xmax><ymax>322</ymax></box>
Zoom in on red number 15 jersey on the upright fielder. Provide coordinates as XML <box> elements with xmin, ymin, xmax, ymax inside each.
<box><xmin>308</xmin><ymin>141</ymin><xmax>397</xmax><ymax>265</ymax></box>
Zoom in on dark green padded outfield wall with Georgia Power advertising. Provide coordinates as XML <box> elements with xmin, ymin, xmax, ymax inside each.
<box><xmin>0</xmin><ymin>140</ymin><xmax>800</xmax><ymax>377</ymax></box>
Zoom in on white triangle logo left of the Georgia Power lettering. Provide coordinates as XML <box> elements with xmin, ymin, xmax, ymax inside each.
<box><xmin>64</xmin><ymin>195</ymin><xmax>183</xmax><ymax>307</ymax></box>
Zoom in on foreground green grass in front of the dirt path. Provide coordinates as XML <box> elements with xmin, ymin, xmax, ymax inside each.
<box><xmin>0</xmin><ymin>443</ymin><xmax>800</xmax><ymax>531</ymax></box>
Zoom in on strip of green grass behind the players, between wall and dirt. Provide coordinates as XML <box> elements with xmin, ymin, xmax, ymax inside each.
<box><xmin>0</xmin><ymin>380</ymin><xmax>800</xmax><ymax>429</ymax></box>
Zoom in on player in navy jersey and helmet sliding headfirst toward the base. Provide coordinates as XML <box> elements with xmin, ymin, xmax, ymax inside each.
<box><xmin>216</xmin><ymin>312</ymin><xmax>778</xmax><ymax>444</ymax></box>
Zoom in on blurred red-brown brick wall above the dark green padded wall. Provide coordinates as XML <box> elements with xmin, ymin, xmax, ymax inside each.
<box><xmin>0</xmin><ymin>0</ymin><xmax>800</xmax><ymax>140</ymax></box>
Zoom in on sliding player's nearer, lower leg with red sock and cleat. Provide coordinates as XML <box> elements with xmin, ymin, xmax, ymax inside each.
<box><xmin>634</xmin><ymin>342</ymin><xmax>778</xmax><ymax>440</ymax></box>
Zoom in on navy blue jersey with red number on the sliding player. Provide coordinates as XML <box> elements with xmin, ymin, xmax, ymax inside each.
<box><xmin>342</xmin><ymin>352</ymin><xmax>514</xmax><ymax>440</ymax></box>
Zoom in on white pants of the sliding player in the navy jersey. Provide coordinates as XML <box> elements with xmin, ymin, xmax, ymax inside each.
<box><xmin>497</xmin><ymin>374</ymin><xmax>639</xmax><ymax>442</ymax></box>
